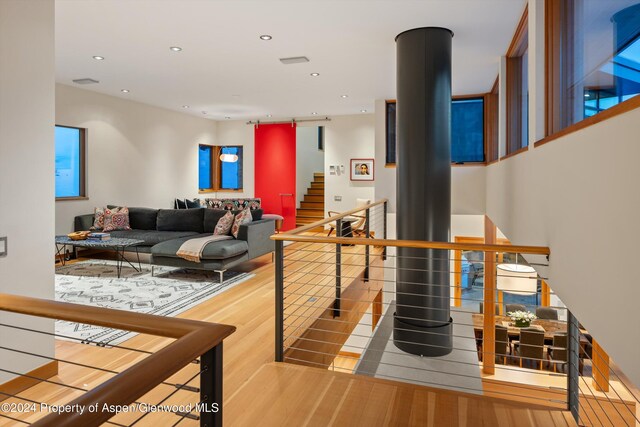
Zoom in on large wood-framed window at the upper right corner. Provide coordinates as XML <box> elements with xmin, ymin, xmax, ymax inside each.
<box><xmin>545</xmin><ymin>0</ymin><xmax>640</xmax><ymax>135</ymax></box>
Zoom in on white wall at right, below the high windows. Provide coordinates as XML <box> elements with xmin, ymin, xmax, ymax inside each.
<box><xmin>487</xmin><ymin>109</ymin><xmax>640</xmax><ymax>384</ymax></box>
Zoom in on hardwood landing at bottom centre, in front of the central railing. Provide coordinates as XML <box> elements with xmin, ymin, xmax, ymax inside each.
<box><xmin>224</xmin><ymin>362</ymin><xmax>576</xmax><ymax>427</ymax></box>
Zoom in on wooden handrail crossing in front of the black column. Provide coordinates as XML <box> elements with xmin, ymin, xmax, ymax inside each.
<box><xmin>271</xmin><ymin>233</ymin><xmax>551</xmax><ymax>255</ymax></box>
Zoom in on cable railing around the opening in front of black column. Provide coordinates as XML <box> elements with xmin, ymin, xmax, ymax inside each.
<box><xmin>272</xmin><ymin>201</ymin><xmax>640</xmax><ymax>426</ymax></box>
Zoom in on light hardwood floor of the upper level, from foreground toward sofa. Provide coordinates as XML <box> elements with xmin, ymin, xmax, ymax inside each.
<box><xmin>0</xmin><ymin>249</ymin><xmax>574</xmax><ymax>426</ymax></box>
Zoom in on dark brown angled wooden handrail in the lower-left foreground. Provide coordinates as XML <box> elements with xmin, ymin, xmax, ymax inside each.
<box><xmin>0</xmin><ymin>294</ymin><xmax>236</xmax><ymax>427</ymax></box>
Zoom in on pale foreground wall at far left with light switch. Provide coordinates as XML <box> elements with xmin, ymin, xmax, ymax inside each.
<box><xmin>0</xmin><ymin>0</ymin><xmax>55</xmax><ymax>383</ymax></box>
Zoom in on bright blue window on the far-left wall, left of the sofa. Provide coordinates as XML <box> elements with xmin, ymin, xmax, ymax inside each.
<box><xmin>55</xmin><ymin>126</ymin><xmax>86</xmax><ymax>200</ymax></box>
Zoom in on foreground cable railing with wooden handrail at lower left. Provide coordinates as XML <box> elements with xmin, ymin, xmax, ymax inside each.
<box><xmin>0</xmin><ymin>294</ymin><xmax>235</xmax><ymax>427</ymax></box>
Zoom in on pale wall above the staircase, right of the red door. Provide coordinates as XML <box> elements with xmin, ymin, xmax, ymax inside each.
<box><xmin>296</xmin><ymin>126</ymin><xmax>324</xmax><ymax>207</ymax></box>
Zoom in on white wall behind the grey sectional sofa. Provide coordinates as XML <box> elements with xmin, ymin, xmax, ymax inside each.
<box><xmin>55</xmin><ymin>84</ymin><xmax>220</xmax><ymax>234</ymax></box>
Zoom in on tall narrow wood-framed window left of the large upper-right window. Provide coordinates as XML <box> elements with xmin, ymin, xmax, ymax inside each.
<box><xmin>506</xmin><ymin>6</ymin><xmax>529</xmax><ymax>154</ymax></box>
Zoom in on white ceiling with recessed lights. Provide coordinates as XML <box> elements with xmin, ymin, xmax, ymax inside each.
<box><xmin>56</xmin><ymin>0</ymin><xmax>525</xmax><ymax>121</ymax></box>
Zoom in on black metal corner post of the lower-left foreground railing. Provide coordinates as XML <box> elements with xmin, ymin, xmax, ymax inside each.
<box><xmin>200</xmin><ymin>342</ymin><xmax>222</xmax><ymax>427</ymax></box>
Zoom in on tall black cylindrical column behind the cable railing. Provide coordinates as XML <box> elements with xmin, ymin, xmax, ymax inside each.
<box><xmin>393</xmin><ymin>27</ymin><xmax>453</xmax><ymax>356</ymax></box>
